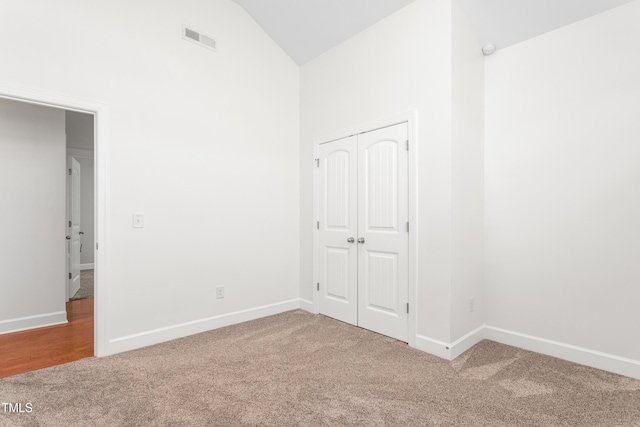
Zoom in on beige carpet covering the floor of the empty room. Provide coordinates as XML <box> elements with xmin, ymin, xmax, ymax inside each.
<box><xmin>0</xmin><ymin>310</ymin><xmax>640</xmax><ymax>427</ymax></box>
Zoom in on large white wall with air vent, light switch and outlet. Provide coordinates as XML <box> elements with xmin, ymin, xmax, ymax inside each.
<box><xmin>0</xmin><ymin>0</ymin><xmax>299</xmax><ymax>351</ymax></box>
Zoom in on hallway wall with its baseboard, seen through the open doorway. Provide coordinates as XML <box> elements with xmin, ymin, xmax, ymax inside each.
<box><xmin>0</xmin><ymin>98</ymin><xmax>67</xmax><ymax>333</ymax></box>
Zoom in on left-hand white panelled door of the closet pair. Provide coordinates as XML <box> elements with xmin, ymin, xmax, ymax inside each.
<box><xmin>318</xmin><ymin>136</ymin><xmax>358</xmax><ymax>325</ymax></box>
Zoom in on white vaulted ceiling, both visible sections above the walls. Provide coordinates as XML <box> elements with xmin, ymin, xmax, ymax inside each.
<box><xmin>234</xmin><ymin>0</ymin><xmax>637</xmax><ymax>65</ymax></box>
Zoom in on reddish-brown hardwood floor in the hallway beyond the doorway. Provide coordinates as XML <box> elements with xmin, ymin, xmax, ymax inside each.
<box><xmin>0</xmin><ymin>298</ymin><xmax>93</xmax><ymax>378</ymax></box>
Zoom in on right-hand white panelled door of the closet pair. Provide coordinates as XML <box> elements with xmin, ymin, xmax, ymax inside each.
<box><xmin>358</xmin><ymin>123</ymin><xmax>409</xmax><ymax>341</ymax></box>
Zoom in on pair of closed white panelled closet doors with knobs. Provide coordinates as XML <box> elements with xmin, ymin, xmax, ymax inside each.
<box><xmin>318</xmin><ymin>123</ymin><xmax>409</xmax><ymax>341</ymax></box>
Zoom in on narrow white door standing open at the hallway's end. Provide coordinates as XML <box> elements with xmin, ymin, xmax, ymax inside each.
<box><xmin>67</xmin><ymin>157</ymin><xmax>81</xmax><ymax>300</ymax></box>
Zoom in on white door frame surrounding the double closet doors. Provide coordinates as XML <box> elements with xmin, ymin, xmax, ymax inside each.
<box><xmin>311</xmin><ymin>110</ymin><xmax>418</xmax><ymax>347</ymax></box>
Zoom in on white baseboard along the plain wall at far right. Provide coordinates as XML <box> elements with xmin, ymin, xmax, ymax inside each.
<box><xmin>484</xmin><ymin>326</ymin><xmax>640</xmax><ymax>380</ymax></box>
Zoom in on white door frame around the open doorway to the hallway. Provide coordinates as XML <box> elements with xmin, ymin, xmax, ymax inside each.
<box><xmin>0</xmin><ymin>82</ymin><xmax>109</xmax><ymax>357</ymax></box>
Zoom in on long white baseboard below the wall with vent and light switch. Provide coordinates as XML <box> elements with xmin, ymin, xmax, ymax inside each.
<box><xmin>105</xmin><ymin>299</ymin><xmax>300</xmax><ymax>356</ymax></box>
